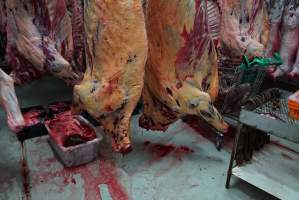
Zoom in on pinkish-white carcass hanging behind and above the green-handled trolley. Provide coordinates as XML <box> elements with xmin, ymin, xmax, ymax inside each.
<box><xmin>218</xmin><ymin>0</ymin><xmax>269</xmax><ymax>59</ymax></box>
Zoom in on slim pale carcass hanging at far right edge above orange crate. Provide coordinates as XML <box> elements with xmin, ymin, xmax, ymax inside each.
<box><xmin>273</xmin><ymin>0</ymin><xmax>299</xmax><ymax>78</ymax></box>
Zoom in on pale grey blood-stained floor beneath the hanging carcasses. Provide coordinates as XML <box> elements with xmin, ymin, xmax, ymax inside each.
<box><xmin>0</xmin><ymin>77</ymin><xmax>274</xmax><ymax>200</ymax></box>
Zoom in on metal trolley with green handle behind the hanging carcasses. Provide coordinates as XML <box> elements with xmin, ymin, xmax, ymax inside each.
<box><xmin>215</xmin><ymin>53</ymin><xmax>283</xmax><ymax>150</ymax></box>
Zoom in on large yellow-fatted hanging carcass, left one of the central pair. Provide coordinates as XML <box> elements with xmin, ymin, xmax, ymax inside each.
<box><xmin>74</xmin><ymin>0</ymin><xmax>147</xmax><ymax>151</ymax></box>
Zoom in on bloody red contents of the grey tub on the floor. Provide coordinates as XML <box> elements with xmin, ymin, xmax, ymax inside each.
<box><xmin>45</xmin><ymin>110</ymin><xmax>97</xmax><ymax>147</ymax></box>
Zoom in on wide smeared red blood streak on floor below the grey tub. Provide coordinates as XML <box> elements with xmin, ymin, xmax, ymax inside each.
<box><xmin>32</xmin><ymin>160</ymin><xmax>129</xmax><ymax>200</ymax></box>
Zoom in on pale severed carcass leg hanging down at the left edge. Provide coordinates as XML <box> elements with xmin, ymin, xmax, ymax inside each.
<box><xmin>0</xmin><ymin>69</ymin><xmax>25</xmax><ymax>132</ymax></box>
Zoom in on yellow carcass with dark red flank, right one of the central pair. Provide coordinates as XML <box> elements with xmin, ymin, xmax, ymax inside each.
<box><xmin>139</xmin><ymin>0</ymin><xmax>228</xmax><ymax>131</ymax></box>
